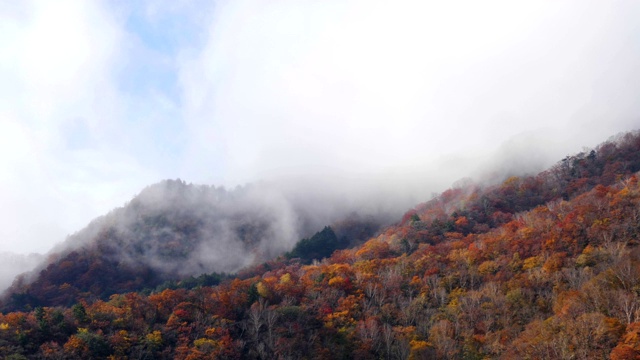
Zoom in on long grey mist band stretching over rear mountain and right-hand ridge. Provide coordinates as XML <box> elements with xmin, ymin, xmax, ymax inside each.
<box><xmin>0</xmin><ymin>129</ymin><xmax>620</xmax><ymax>296</ymax></box>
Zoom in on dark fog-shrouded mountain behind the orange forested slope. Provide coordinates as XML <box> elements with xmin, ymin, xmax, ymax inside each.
<box><xmin>4</xmin><ymin>180</ymin><xmax>386</xmax><ymax>310</ymax></box>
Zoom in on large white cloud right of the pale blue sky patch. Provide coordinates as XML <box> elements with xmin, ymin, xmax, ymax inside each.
<box><xmin>181</xmin><ymin>1</ymin><xmax>639</xmax><ymax>187</ymax></box>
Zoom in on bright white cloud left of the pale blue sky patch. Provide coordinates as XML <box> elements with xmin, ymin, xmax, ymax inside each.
<box><xmin>0</xmin><ymin>1</ymin><xmax>158</xmax><ymax>252</ymax></box>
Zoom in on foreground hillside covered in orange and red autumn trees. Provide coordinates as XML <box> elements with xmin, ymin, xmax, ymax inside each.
<box><xmin>0</xmin><ymin>133</ymin><xmax>640</xmax><ymax>360</ymax></box>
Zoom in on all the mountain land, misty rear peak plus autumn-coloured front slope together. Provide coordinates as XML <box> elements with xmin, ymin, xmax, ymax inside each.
<box><xmin>0</xmin><ymin>131</ymin><xmax>640</xmax><ymax>359</ymax></box>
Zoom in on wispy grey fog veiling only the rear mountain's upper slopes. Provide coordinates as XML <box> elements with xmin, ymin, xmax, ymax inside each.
<box><xmin>40</xmin><ymin>180</ymin><xmax>399</xmax><ymax>284</ymax></box>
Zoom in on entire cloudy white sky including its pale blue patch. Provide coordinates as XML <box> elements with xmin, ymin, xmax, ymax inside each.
<box><xmin>0</xmin><ymin>0</ymin><xmax>640</xmax><ymax>253</ymax></box>
